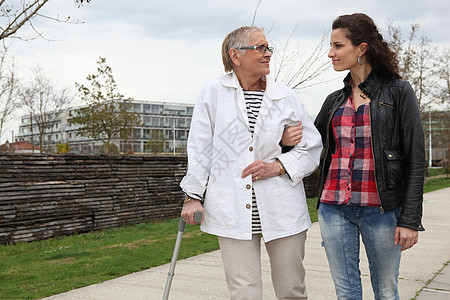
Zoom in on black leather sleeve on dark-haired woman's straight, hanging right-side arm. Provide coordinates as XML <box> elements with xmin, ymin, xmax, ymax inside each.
<box><xmin>397</xmin><ymin>81</ymin><xmax>425</xmax><ymax>231</ymax></box>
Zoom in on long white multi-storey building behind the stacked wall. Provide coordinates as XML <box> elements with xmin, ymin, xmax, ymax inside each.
<box><xmin>16</xmin><ymin>100</ymin><xmax>194</xmax><ymax>153</ymax></box>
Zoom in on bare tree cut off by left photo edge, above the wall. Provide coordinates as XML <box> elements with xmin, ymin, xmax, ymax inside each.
<box><xmin>0</xmin><ymin>50</ymin><xmax>19</xmax><ymax>142</ymax></box>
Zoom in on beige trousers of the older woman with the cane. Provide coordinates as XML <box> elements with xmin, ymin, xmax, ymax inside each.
<box><xmin>219</xmin><ymin>230</ymin><xmax>308</xmax><ymax>300</ymax></box>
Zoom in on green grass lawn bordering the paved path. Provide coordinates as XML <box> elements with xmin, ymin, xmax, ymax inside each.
<box><xmin>0</xmin><ymin>178</ymin><xmax>450</xmax><ymax>299</ymax></box>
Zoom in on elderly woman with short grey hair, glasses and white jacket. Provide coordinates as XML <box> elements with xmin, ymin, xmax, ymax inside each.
<box><xmin>180</xmin><ymin>27</ymin><xmax>322</xmax><ymax>299</ymax></box>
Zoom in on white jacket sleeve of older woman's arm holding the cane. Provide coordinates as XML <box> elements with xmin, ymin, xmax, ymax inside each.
<box><xmin>180</xmin><ymin>84</ymin><xmax>214</xmax><ymax>195</ymax></box>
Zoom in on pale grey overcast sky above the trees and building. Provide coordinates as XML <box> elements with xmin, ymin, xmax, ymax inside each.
<box><xmin>1</xmin><ymin>0</ymin><xmax>450</xmax><ymax>143</ymax></box>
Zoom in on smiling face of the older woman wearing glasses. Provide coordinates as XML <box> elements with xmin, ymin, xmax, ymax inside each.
<box><xmin>235</xmin><ymin>31</ymin><xmax>272</xmax><ymax>78</ymax></box>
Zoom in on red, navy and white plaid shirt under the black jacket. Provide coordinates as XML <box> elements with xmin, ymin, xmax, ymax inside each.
<box><xmin>320</xmin><ymin>95</ymin><xmax>380</xmax><ymax>206</ymax></box>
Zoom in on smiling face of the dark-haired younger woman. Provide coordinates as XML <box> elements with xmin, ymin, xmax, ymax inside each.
<box><xmin>328</xmin><ymin>28</ymin><xmax>364</xmax><ymax>71</ymax></box>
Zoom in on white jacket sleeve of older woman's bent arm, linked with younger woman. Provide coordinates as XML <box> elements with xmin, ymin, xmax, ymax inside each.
<box><xmin>278</xmin><ymin>99</ymin><xmax>322</xmax><ymax>186</ymax></box>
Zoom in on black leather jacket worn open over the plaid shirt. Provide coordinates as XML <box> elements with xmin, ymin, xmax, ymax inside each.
<box><xmin>315</xmin><ymin>72</ymin><xmax>425</xmax><ymax>231</ymax></box>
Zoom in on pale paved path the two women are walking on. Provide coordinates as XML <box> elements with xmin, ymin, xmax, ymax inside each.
<box><xmin>45</xmin><ymin>188</ymin><xmax>450</xmax><ymax>300</ymax></box>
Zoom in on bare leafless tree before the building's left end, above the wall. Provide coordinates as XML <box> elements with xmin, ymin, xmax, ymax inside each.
<box><xmin>20</xmin><ymin>67</ymin><xmax>72</xmax><ymax>153</ymax></box>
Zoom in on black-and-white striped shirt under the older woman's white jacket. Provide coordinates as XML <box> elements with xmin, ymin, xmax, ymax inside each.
<box><xmin>244</xmin><ymin>90</ymin><xmax>264</xmax><ymax>234</ymax></box>
